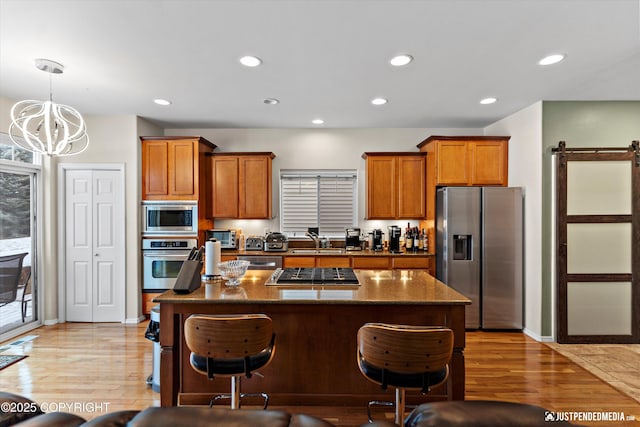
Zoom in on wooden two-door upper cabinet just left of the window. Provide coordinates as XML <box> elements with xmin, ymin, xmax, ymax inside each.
<box><xmin>207</xmin><ymin>153</ymin><xmax>275</xmax><ymax>219</ymax></box>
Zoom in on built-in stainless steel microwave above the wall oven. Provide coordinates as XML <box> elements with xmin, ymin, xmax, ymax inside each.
<box><xmin>142</xmin><ymin>201</ymin><xmax>198</xmax><ymax>235</ymax></box>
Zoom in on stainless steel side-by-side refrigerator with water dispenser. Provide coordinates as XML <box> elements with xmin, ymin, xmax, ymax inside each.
<box><xmin>436</xmin><ymin>187</ymin><xmax>524</xmax><ymax>329</ymax></box>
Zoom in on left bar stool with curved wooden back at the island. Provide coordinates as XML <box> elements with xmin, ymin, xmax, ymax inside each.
<box><xmin>184</xmin><ymin>314</ymin><xmax>276</xmax><ymax>409</ymax></box>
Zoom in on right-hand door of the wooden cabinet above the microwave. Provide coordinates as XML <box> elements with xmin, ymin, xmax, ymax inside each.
<box><xmin>169</xmin><ymin>140</ymin><xmax>198</xmax><ymax>200</ymax></box>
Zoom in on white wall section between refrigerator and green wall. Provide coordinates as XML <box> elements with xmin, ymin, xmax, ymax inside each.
<box><xmin>484</xmin><ymin>102</ymin><xmax>546</xmax><ymax>340</ymax></box>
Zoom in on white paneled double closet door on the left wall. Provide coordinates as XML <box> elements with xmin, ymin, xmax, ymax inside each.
<box><xmin>64</xmin><ymin>169</ymin><xmax>125</xmax><ymax>322</ymax></box>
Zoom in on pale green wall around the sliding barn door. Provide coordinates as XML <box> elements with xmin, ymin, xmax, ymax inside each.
<box><xmin>541</xmin><ymin>101</ymin><xmax>640</xmax><ymax>336</ymax></box>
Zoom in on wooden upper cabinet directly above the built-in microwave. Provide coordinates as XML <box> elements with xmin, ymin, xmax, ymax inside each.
<box><xmin>140</xmin><ymin>136</ymin><xmax>216</xmax><ymax>200</ymax></box>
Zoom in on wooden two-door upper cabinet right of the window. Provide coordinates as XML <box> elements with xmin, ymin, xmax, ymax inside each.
<box><xmin>363</xmin><ymin>153</ymin><xmax>426</xmax><ymax>219</ymax></box>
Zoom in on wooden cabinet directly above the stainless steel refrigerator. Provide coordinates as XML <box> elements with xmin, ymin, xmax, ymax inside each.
<box><xmin>418</xmin><ymin>136</ymin><xmax>509</xmax><ymax>186</ymax></box>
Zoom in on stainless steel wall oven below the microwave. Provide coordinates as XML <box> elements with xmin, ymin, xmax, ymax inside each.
<box><xmin>142</xmin><ymin>238</ymin><xmax>198</xmax><ymax>292</ymax></box>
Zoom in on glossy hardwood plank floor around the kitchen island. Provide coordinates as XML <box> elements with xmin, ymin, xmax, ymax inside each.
<box><xmin>0</xmin><ymin>322</ymin><xmax>640</xmax><ymax>426</ymax></box>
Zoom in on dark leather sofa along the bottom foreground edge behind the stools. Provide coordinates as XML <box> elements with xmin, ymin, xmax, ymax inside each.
<box><xmin>0</xmin><ymin>392</ymin><xmax>575</xmax><ymax>427</ymax></box>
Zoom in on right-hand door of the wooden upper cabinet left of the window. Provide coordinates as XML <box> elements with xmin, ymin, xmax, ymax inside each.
<box><xmin>238</xmin><ymin>156</ymin><xmax>271</xmax><ymax>219</ymax></box>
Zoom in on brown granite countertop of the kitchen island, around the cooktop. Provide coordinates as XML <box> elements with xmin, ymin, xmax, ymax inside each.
<box><xmin>153</xmin><ymin>270</ymin><xmax>471</xmax><ymax>305</ymax></box>
